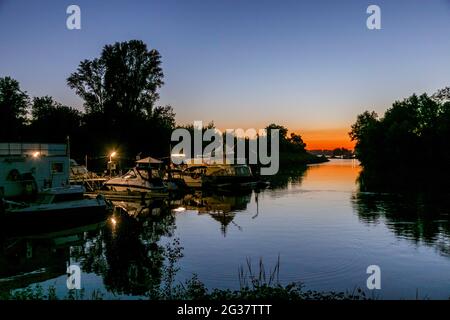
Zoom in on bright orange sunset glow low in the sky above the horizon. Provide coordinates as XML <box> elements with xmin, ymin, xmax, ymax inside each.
<box><xmin>293</xmin><ymin>128</ymin><xmax>355</xmax><ymax>150</ymax></box>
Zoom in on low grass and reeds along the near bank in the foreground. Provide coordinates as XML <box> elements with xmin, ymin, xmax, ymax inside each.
<box><xmin>0</xmin><ymin>259</ymin><xmax>367</xmax><ymax>301</ymax></box>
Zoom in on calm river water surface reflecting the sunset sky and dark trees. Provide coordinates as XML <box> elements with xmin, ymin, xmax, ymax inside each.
<box><xmin>0</xmin><ymin>160</ymin><xmax>450</xmax><ymax>299</ymax></box>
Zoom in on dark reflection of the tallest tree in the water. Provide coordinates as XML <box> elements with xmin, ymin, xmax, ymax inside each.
<box><xmin>72</xmin><ymin>202</ymin><xmax>181</xmax><ymax>296</ymax></box>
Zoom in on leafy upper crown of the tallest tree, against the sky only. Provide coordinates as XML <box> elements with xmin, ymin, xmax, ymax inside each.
<box><xmin>67</xmin><ymin>40</ymin><xmax>164</xmax><ymax>117</ymax></box>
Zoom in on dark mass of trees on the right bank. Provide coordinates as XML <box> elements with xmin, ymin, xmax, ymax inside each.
<box><xmin>350</xmin><ymin>88</ymin><xmax>450</xmax><ymax>192</ymax></box>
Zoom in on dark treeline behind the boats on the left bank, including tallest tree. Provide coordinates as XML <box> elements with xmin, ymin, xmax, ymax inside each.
<box><xmin>0</xmin><ymin>40</ymin><xmax>327</xmax><ymax>168</ymax></box>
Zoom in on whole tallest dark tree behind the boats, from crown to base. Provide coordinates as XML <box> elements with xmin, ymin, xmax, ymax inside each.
<box><xmin>67</xmin><ymin>40</ymin><xmax>175</xmax><ymax>159</ymax></box>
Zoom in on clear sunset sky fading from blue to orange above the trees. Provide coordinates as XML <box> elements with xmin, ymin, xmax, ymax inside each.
<box><xmin>0</xmin><ymin>0</ymin><xmax>450</xmax><ymax>149</ymax></box>
